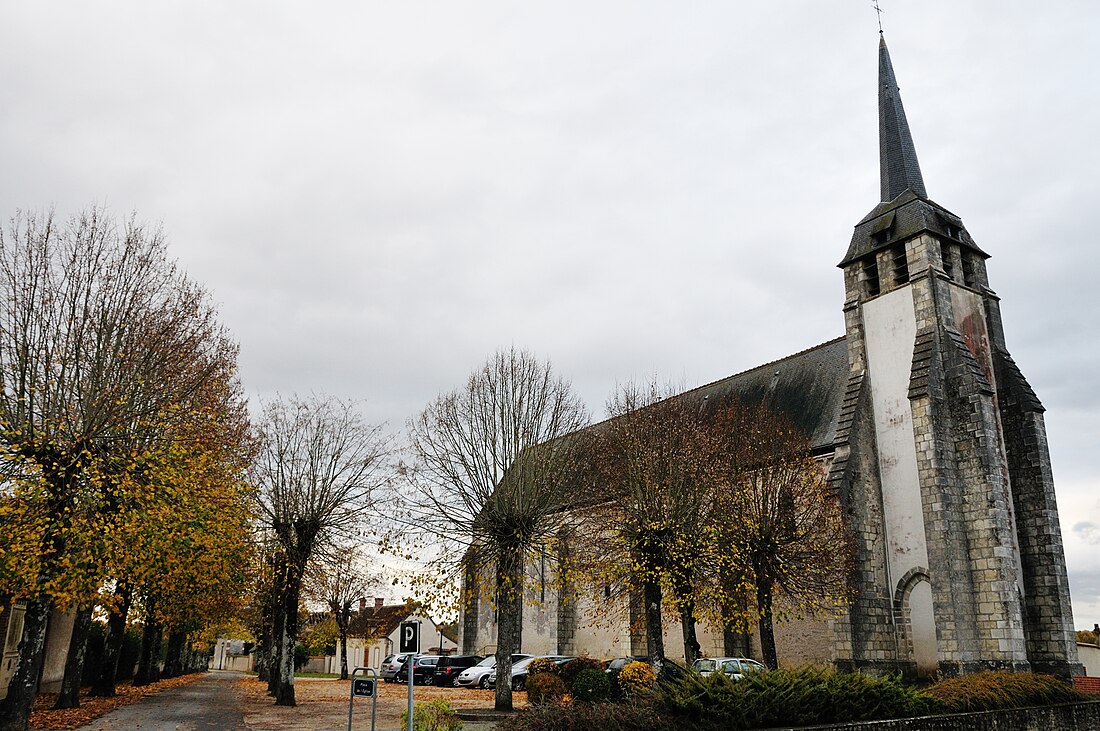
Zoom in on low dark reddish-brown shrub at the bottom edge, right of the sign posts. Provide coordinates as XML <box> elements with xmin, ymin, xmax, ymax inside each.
<box><xmin>496</xmin><ymin>694</ymin><xmax>685</xmax><ymax>731</ymax></box>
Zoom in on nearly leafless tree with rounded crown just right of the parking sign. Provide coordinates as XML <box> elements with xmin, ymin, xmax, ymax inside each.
<box><xmin>408</xmin><ymin>348</ymin><xmax>589</xmax><ymax>710</ymax></box>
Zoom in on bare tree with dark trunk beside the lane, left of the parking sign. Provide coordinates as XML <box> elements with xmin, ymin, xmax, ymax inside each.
<box><xmin>254</xmin><ymin>396</ymin><xmax>388</xmax><ymax>706</ymax></box>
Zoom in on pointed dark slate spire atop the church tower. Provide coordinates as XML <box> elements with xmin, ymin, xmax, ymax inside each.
<box><xmin>879</xmin><ymin>34</ymin><xmax>928</xmax><ymax>201</ymax></box>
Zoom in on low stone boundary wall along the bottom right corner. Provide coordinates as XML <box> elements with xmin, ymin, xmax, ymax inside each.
<box><xmin>792</xmin><ymin>700</ymin><xmax>1100</xmax><ymax>731</ymax></box>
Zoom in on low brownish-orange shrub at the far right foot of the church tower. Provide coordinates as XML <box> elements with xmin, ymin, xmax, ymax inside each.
<box><xmin>925</xmin><ymin>673</ymin><xmax>1091</xmax><ymax>713</ymax></box>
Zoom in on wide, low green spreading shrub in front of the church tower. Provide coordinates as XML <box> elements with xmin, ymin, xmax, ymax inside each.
<box><xmin>660</xmin><ymin>667</ymin><xmax>939</xmax><ymax>729</ymax></box>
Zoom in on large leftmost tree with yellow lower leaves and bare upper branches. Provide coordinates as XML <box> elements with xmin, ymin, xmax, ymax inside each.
<box><xmin>0</xmin><ymin>209</ymin><xmax>239</xmax><ymax>731</ymax></box>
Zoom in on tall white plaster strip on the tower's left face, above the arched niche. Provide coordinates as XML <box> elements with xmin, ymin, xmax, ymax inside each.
<box><xmin>864</xmin><ymin>287</ymin><xmax>928</xmax><ymax>587</ymax></box>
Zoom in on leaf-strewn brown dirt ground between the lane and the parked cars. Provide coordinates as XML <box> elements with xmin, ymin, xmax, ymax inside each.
<box><xmin>238</xmin><ymin>677</ymin><xmax>527</xmax><ymax>731</ymax></box>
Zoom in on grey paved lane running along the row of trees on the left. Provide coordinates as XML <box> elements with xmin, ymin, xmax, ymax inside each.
<box><xmin>80</xmin><ymin>671</ymin><xmax>248</xmax><ymax>731</ymax></box>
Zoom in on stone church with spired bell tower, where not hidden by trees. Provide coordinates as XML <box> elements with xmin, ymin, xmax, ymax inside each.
<box><xmin>460</xmin><ymin>36</ymin><xmax>1080</xmax><ymax>677</ymax></box>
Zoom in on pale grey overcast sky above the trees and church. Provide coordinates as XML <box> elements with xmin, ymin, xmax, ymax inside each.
<box><xmin>0</xmin><ymin>0</ymin><xmax>1100</xmax><ymax>628</ymax></box>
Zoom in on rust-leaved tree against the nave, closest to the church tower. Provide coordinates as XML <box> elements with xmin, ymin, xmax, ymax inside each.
<box><xmin>713</xmin><ymin>399</ymin><xmax>853</xmax><ymax>667</ymax></box>
